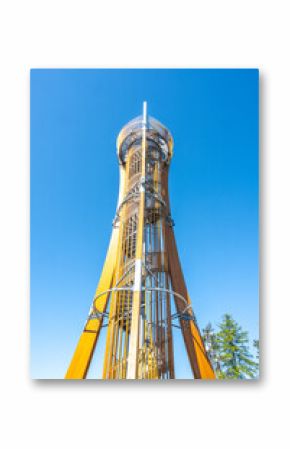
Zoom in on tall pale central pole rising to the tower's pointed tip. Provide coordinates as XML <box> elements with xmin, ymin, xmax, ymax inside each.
<box><xmin>127</xmin><ymin>101</ymin><xmax>147</xmax><ymax>379</ymax></box>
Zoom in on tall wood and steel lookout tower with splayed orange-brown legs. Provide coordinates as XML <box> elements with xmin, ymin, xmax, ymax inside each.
<box><xmin>65</xmin><ymin>102</ymin><xmax>215</xmax><ymax>379</ymax></box>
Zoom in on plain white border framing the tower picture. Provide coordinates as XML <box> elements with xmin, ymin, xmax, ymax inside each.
<box><xmin>0</xmin><ymin>0</ymin><xmax>290</xmax><ymax>449</ymax></box>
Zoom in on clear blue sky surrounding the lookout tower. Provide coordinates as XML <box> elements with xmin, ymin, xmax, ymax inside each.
<box><xmin>30</xmin><ymin>69</ymin><xmax>259</xmax><ymax>378</ymax></box>
